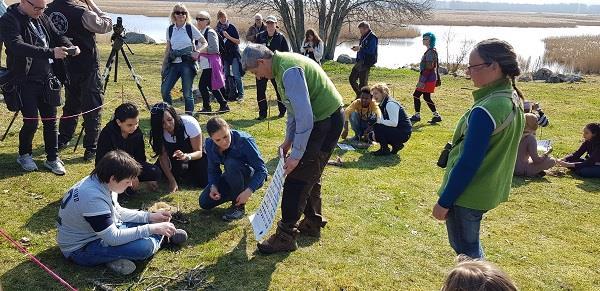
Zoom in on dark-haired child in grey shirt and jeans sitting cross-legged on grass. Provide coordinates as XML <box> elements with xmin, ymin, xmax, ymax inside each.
<box><xmin>57</xmin><ymin>150</ymin><xmax>187</xmax><ymax>275</ymax></box>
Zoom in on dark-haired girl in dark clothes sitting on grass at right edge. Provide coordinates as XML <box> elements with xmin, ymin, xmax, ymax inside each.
<box><xmin>558</xmin><ymin>123</ymin><xmax>600</xmax><ymax>178</ymax></box>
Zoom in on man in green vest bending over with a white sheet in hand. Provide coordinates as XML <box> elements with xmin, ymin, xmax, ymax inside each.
<box><xmin>242</xmin><ymin>44</ymin><xmax>344</xmax><ymax>254</ymax></box>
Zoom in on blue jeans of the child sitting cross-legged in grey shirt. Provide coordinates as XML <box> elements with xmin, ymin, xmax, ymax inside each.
<box><xmin>69</xmin><ymin>223</ymin><xmax>161</xmax><ymax>267</ymax></box>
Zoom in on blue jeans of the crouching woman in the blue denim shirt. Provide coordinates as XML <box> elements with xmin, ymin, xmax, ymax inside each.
<box><xmin>198</xmin><ymin>158</ymin><xmax>253</xmax><ymax>209</ymax></box>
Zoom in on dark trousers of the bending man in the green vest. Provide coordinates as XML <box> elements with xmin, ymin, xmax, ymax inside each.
<box><xmin>281</xmin><ymin>108</ymin><xmax>344</xmax><ymax>229</ymax></box>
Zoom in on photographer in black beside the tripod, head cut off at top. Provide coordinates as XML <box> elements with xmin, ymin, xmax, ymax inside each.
<box><xmin>45</xmin><ymin>0</ymin><xmax>117</xmax><ymax>161</ymax></box>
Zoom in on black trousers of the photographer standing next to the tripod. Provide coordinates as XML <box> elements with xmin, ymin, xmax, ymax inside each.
<box><xmin>58</xmin><ymin>69</ymin><xmax>104</xmax><ymax>151</ymax></box>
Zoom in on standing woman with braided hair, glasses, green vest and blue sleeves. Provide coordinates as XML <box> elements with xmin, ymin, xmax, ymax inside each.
<box><xmin>433</xmin><ymin>39</ymin><xmax>524</xmax><ymax>258</ymax></box>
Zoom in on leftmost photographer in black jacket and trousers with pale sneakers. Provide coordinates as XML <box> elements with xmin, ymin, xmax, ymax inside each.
<box><xmin>0</xmin><ymin>0</ymin><xmax>80</xmax><ymax>175</ymax></box>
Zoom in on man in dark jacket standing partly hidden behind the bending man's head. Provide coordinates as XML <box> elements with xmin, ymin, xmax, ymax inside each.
<box><xmin>256</xmin><ymin>15</ymin><xmax>290</xmax><ymax>120</ymax></box>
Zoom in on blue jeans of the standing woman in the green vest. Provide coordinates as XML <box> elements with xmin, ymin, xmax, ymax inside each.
<box><xmin>446</xmin><ymin>205</ymin><xmax>486</xmax><ymax>259</ymax></box>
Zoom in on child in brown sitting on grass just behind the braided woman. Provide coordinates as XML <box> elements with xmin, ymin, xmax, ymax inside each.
<box><xmin>515</xmin><ymin>113</ymin><xmax>556</xmax><ymax>177</ymax></box>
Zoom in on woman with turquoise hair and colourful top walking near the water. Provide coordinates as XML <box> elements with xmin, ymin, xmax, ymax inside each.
<box><xmin>410</xmin><ymin>32</ymin><xmax>442</xmax><ymax>124</ymax></box>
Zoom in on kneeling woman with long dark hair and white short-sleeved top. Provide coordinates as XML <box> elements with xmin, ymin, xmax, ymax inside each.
<box><xmin>150</xmin><ymin>102</ymin><xmax>207</xmax><ymax>192</ymax></box>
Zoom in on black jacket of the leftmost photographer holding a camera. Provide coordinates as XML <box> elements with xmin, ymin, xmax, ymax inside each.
<box><xmin>0</xmin><ymin>3</ymin><xmax>73</xmax><ymax>82</ymax></box>
